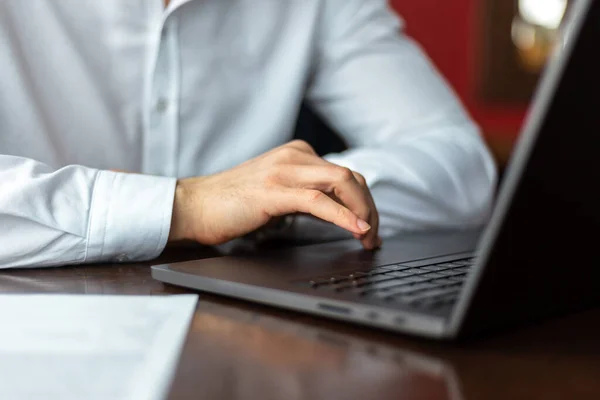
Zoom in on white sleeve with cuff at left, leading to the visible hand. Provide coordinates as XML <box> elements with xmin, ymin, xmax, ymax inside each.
<box><xmin>0</xmin><ymin>155</ymin><xmax>176</xmax><ymax>268</ymax></box>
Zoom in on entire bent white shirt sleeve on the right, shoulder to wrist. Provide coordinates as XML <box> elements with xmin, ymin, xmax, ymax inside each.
<box><xmin>299</xmin><ymin>0</ymin><xmax>497</xmax><ymax>237</ymax></box>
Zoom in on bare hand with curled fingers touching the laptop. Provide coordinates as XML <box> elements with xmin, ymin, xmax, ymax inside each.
<box><xmin>169</xmin><ymin>141</ymin><xmax>381</xmax><ymax>249</ymax></box>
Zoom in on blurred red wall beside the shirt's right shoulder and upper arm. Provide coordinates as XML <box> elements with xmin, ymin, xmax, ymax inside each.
<box><xmin>390</xmin><ymin>0</ymin><xmax>526</xmax><ymax>158</ymax></box>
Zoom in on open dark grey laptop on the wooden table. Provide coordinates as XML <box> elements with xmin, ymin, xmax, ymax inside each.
<box><xmin>152</xmin><ymin>0</ymin><xmax>600</xmax><ymax>340</ymax></box>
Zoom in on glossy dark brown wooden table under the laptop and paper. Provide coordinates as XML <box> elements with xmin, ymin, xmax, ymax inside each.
<box><xmin>0</xmin><ymin>244</ymin><xmax>600</xmax><ymax>400</ymax></box>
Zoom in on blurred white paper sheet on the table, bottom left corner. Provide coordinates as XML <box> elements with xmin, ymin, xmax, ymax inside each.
<box><xmin>0</xmin><ymin>295</ymin><xmax>197</xmax><ymax>400</ymax></box>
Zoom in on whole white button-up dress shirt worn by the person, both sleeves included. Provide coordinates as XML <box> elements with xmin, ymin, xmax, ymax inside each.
<box><xmin>0</xmin><ymin>0</ymin><xmax>496</xmax><ymax>268</ymax></box>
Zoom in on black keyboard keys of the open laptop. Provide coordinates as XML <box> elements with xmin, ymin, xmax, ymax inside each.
<box><xmin>306</xmin><ymin>258</ymin><xmax>475</xmax><ymax>309</ymax></box>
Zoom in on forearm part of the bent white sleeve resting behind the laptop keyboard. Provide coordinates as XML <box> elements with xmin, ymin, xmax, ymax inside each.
<box><xmin>327</xmin><ymin>123</ymin><xmax>497</xmax><ymax>236</ymax></box>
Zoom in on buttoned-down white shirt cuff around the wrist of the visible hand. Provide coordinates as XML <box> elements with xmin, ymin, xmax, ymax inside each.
<box><xmin>85</xmin><ymin>171</ymin><xmax>177</xmax><ymax>262</ymax></box>
